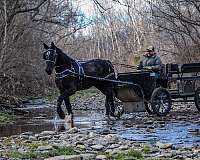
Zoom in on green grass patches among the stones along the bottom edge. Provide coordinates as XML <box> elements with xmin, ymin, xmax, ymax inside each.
<box><xmin>0</xmin><ymin>141</ymin><xmax>158</xmax><ymax>160</ymax></box>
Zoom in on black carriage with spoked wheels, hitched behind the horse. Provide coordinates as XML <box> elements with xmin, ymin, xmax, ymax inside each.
<box><xmin>115</xmin><ymin>63</ymin><xmax>200</xmax><ymax>116</ymax></box>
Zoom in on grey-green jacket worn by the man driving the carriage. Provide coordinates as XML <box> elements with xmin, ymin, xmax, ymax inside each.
<box><xmin>139</xmin><ymin>55</ymin><xmax>162</xmax><ymax>72</ymax></box>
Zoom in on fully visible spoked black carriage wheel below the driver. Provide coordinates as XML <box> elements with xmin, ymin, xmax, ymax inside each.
<box><xmin>151</xmin><ymin>87</ymin><xmax>172</xmax><ymax>116</ymax></box>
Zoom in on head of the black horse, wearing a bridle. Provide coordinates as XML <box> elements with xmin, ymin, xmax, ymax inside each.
<box><xmin>43</xmin><ymin>42</ymin><xmax>58</xmax><ymax>75</ymax></box>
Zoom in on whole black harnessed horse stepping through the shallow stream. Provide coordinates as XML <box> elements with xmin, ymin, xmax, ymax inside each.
<box><xmin>43</xmin><ymin>42</ymin><xmax>115</xmax><ymax>122</ymax></box>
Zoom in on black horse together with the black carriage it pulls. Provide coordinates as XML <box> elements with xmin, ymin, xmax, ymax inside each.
<box><xmin>43</xmin><ymin>42</ymin><xmax>200</xmax><ymax>118</ymax></box>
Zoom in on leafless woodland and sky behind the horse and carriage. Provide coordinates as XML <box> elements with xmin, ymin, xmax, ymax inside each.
<box><xmin>0</xmin><ymin>0</ymin><xmax>200</xmax><ymax>96</ymax></box>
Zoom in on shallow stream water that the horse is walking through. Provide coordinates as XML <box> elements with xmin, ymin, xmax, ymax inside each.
<box><xmin>0</xmin><ymin>100</ymin><xmax>200</xmax><ymax>145</ymax></box>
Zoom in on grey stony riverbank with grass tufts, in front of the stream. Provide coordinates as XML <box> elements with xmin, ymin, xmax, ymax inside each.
<box><xmin>0</xmin><ymin>128</ymin><xmax>200</xmax><ymax>160</ymax></box>
